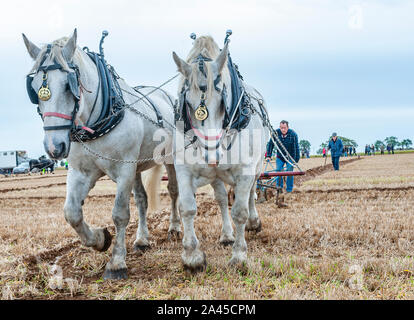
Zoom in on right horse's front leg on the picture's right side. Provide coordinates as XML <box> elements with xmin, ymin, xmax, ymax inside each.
<box><xmin>229</xmin><ymin>176</ymin><xmax>255</xmax><ymax>266</ymax></box>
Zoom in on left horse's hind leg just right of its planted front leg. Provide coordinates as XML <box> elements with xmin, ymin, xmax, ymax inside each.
<box><xmin>133</xmin><ymin>172</ymin><xmax>150</xmax><ymax>252</ymax></box>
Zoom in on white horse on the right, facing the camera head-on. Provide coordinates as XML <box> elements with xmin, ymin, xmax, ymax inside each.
<box><xmin>173</xmin><ymin>36</ymin><xmax>270</xmax><ymax>271</ymax></box>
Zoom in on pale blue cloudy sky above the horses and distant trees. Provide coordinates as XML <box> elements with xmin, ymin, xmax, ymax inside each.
<box><xmin>0</xmin><ymin>0</ymin><xmax>414</xmax><ymax>158</ymax></box>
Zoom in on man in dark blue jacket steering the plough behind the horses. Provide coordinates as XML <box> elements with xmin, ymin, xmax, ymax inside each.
<box><xmin>266</xmin><ymin>120</ymin><xmax>300</xmax><ymax>192</ymax></box>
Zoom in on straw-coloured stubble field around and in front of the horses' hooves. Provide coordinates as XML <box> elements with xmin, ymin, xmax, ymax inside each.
<box><xmin>0</xmin><ymin>154</ymin><xmax>414</xmax><ymax>299</ymax></box>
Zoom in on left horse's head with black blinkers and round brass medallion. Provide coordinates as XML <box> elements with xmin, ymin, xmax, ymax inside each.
<box><xmin>23</xmin><ymin>29</ymin><xmax>98</xmax><ymax>159</ymax></box>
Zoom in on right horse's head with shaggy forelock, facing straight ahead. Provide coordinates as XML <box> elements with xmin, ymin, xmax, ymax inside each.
<box><xmin>173</xmin><ymin>36</ymin><xmax>231</xmax><ymax>161</ymax></box>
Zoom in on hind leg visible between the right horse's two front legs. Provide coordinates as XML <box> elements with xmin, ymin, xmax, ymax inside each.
<box><xmin>211</xmin><ymin>180</ymin><xmax>234</xmax><ymax>246</ymax></box>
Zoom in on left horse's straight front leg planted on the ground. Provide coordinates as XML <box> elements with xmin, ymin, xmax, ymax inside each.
<box><xmin>103</xmin><ymin>170</ymin><xmax>136</xmax><ymax>280</ymax></box>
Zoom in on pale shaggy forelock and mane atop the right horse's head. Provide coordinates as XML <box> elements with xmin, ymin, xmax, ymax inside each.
<box><xmin>180</xmin><ymin>36</ymin><xmax>230</xmax><ymax>98</ymax></box>
